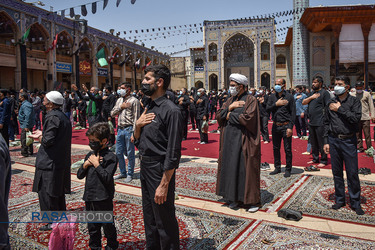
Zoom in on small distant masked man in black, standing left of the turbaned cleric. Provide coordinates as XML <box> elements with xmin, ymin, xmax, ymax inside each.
<box><xmin>196</xmin><ymin>88</ymin><xmax>209</xmax><ymax>144</ymax></box>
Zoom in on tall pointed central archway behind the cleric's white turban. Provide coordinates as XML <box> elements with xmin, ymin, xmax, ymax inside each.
<box><xmin>224</xmin><ymin>34</ymin><xmax>254</xmax><ymax>87</ymax></box>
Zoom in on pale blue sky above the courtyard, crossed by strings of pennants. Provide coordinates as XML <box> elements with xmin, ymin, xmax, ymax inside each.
<box><xmin>32</xmin><ymin>0</ymin><xmax>374</xmax><ymax>56</ymax></box>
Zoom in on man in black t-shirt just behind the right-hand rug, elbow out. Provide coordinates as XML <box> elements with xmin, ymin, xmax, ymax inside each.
<box><xmin>302</xmin><ymin>76</ymin><xmax>331</xmax><ymax>167</ymax></box>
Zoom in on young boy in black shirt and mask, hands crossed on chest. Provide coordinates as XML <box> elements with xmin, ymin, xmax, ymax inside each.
<box><xmin>77</xmin><ymin>122</ymin><xmax>119</xmax><ymax>249</ymax></box>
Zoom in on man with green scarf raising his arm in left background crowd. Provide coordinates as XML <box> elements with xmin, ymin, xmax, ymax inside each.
<box><xmin>72</xmin><ymin>84</ymin><xmax>103</xmax><ymax>127</ymax></box>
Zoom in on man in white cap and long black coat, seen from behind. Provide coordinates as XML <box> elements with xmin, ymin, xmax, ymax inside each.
<box><xmin>30</xmin><ymin>91</ymin><xmax>72</xmax><ymax>231</ymax></box>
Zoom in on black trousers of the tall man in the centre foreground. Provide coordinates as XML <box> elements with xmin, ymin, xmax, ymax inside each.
<box><xmin>140</xmin><ymin>161</ymin><xmax>180</xmax><ymax>249</ymax></box>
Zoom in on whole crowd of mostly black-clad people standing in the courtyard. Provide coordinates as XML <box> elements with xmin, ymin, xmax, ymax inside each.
<box><xmin>0</xmin><ymin>66</ymin><xmax>375</xmax><ymax>249</ymax></box>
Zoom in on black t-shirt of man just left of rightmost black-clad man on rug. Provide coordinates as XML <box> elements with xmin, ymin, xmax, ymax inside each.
<box><xmin>308</xmin><ymin>89</ymin><xmax>331</xmax><ymax>126</ymax></box>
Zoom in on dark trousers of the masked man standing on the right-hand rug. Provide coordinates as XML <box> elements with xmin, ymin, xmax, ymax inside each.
<box><xmin>328</xmin><ymin>135</ymin><xmax>361</xmax><ymax>209</ymax></box>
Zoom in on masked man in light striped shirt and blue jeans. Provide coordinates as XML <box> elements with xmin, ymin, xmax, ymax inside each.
<box><xmin>111</xmin><ymin>82</ymin><xmax>141</xmax><ymax>182</ymax></box>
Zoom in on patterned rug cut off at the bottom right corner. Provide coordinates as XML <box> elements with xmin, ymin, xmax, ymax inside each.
<box><xmin>229</xmin><ymin>221</ymin><xmax>375</xmax><ymax>249</ymax></box>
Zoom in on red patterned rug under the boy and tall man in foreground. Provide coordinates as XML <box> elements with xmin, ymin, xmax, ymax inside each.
<box><xmin>9</xmin><ymin>189</ymin><xmax>253</xmax><ymax>249</ymax></box>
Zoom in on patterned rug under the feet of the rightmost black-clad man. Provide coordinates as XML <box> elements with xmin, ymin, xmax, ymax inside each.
<box><xmin>277</xmin><ymin>175</ymin><xmax>375</xmax><ymax>225</ymax></box>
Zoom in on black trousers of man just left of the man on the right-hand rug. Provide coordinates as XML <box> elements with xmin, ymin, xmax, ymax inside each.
<box><xmin>309</xmin><ymin>125</ymin><xmax>328</xmax><ymax>164</ymax></box>
